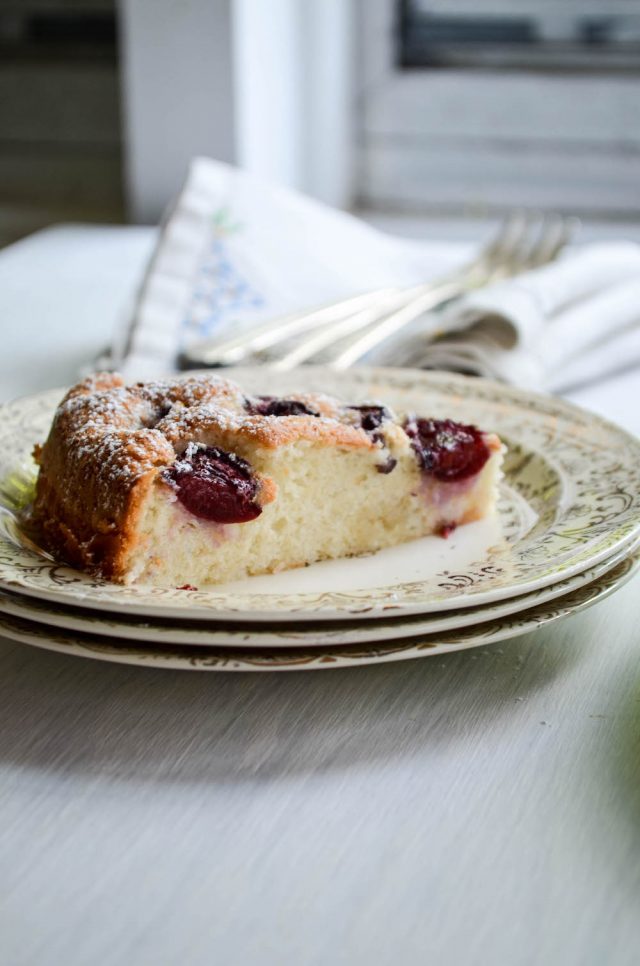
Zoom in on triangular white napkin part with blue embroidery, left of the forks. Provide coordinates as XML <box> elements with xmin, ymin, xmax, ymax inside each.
<box><xmin>115</xmin><ymin>158</ymin><xmax>473</xmax><ymax>379</ymax></box>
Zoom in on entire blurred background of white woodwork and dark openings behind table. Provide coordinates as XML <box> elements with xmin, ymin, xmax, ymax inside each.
<box><xmin>0</xmin><ymin>0</ymin><xmax>640</xmax><ymax>245</ymax></box>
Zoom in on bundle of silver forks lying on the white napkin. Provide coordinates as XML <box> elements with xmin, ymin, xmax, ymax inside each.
<box><xmin>182</xmin><ymin>212</ymin><xmax>572</xmax><ymax>370</ymax></box>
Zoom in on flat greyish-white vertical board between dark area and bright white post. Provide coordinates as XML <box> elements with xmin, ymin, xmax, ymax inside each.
<box><xmin>119</xmin><ymin>0</ymin><xmax>235</xmax><ymax>222</ymax></box>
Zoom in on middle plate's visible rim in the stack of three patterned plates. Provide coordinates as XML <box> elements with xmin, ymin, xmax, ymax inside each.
<box><xmin>0</xmin><ymin>540</ymin><xmax>640</xmax><ymax>650</ymax></box>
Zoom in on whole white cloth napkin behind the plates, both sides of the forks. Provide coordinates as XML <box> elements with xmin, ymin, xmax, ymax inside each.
<box><xmin>111</xmin><ymin>158</ymin><xmax>640</xmax><ymax>391</ymax></box>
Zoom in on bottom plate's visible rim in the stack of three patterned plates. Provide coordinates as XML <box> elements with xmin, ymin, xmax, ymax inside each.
<box><xmin>0</xmin><ymin>556</ymin><xmax>640</xmax><ymax>671</ymax></box>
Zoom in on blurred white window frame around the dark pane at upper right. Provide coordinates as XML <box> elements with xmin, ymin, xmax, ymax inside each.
<box><xmin>357</xmin><ymin>0</ymin><xmax>640</xmax><ymax>215</ymax></box>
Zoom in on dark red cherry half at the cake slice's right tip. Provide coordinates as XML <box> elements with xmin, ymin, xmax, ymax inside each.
<box><xmin>404</xmin><ymin>419</ymin><xmax>490</xmax><ymax>483</ymax></box>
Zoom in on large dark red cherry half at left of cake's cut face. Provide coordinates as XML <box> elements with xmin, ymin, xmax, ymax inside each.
<box><xmin>164</xmin><ymin>446</ymin><xmax>262</xmax><ymax>523</ymax></box>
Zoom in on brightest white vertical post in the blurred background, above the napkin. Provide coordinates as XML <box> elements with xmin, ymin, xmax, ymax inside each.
<box><xmin>233</xmin><ymin>0</ymin><xmax>355</xmax><ymax>207</ymax></box>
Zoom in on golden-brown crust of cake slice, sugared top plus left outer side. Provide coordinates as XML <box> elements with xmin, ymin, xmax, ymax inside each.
<box><xmin>34</xmin><ymin>373</ymin><xmax>384</xmax><ymax>568</ymax></box>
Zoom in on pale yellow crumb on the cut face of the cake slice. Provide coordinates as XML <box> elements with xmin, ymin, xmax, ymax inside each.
<box><xmin>127</xmin><ymin>437</ymin><xmax>501</xmax><ymax>587</ymax></box>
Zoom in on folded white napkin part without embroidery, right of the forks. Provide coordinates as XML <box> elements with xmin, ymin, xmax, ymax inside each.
<box><xmin>394</xmin><ymin>242</ymin><xmax>640</xmax><ymax>391</ymax></box>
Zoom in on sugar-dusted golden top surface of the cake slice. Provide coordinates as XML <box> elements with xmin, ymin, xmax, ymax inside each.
<box><xmin>54</xmin><ymin>373</ymin><xmax>380</xmax><ymax>464</ymax></box>
